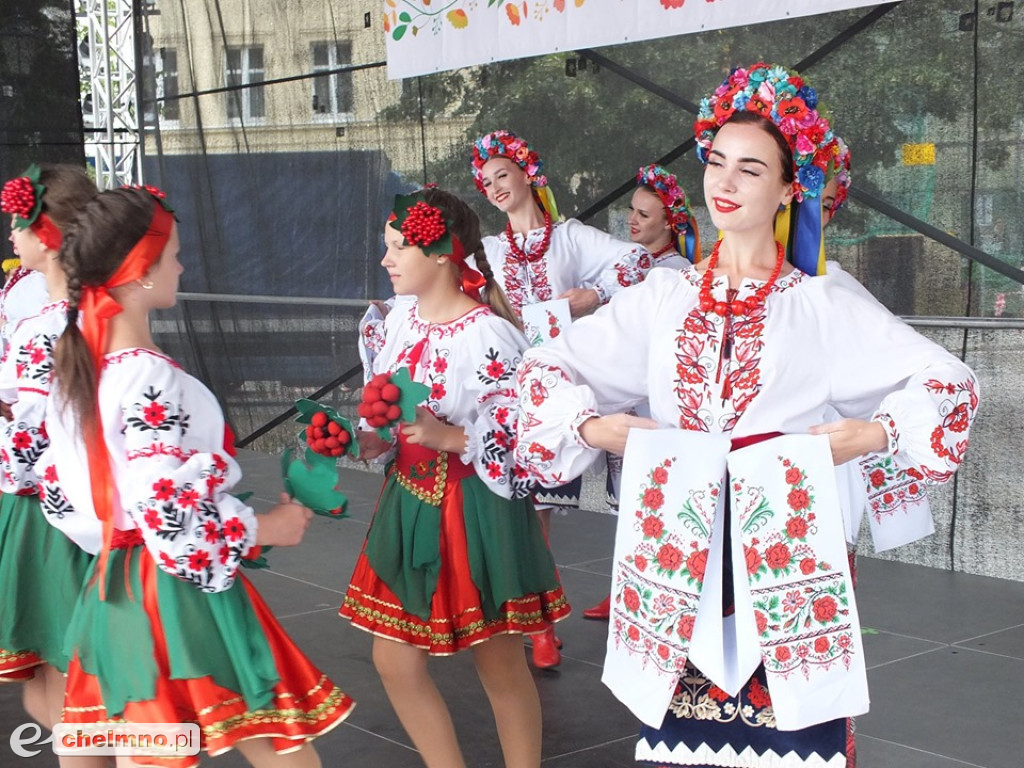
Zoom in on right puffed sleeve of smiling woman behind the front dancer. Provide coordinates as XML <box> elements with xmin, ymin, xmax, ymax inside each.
<box><xmin>562</xmin><ymin>219</ymin><xmax>650</xmax><ymax>304</ymax></box>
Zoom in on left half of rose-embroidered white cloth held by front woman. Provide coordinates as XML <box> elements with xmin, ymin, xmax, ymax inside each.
<box><xmin>601</xmin><ymin>429</ymin><xmax>729</xmax><ymax>727</ymax></box>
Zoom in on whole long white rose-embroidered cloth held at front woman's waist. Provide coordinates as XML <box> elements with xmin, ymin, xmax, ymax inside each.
<box><xmin>602</xmin><ymin>429</ymin><xmax>867</xmax><ymax>730</ymax></box>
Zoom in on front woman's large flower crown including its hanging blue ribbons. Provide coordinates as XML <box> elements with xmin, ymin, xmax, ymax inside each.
<box><xmin>693</xmin><ymin>61</ymin><xmax>837</xmax><ymax>274</ymax></box>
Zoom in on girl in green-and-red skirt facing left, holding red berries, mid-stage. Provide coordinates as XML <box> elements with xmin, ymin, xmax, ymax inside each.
<box><xmin>341</xmin><ymin>189</ymin><xmax>569</xmax><ymax>768</ymax></box>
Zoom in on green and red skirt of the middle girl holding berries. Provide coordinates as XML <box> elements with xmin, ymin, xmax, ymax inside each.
<box><xmin>339</xmin><ymin>442</ymin><xmax>571</xmax><ymax>655</ymax></box>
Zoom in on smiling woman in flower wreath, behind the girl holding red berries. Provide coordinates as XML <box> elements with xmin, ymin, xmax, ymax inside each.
<box><xmin>471</xmin><ymin>130</ymin><xmax>644</xmax><ymax>668</ymax></box>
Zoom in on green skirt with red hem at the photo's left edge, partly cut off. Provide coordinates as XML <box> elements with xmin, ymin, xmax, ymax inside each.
<box><xmin>0</xmin><ymin>494</ymin><xmax>93</xmax><ymax>682</ymax></box>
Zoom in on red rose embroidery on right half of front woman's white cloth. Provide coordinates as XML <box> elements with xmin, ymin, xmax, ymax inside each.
<box><xmin>730</xmin><ymin>457</ymin><xmax>855</xmax><ymax>678</ymax></box>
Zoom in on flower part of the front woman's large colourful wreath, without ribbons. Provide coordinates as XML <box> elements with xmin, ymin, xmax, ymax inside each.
<box><xmin>693</xmin><ymin>61</ymin><xmax>836</xmax><ymax>202</ymax></box>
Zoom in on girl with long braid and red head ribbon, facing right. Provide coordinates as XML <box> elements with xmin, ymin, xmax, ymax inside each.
<box><xmin>40</xmin><ymin>188</ymin><xmax>353</xmax><ymax>768</ymax></box>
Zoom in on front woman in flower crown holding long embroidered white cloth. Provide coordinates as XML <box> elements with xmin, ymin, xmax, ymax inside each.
<box><xmin>517</xmin><ymin>63</ymin><xmax>978</xmax><ymax>768</ymax></box>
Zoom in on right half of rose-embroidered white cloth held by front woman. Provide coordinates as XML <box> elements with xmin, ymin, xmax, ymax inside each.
<box><xmin>728</xmin><ymin>435</ymin><xmax>868</xmax><ymax>730</ymax></box>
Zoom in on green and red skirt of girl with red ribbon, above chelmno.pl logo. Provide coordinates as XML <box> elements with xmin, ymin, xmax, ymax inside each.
<box><xmin>63</xmin><ymin>536</ymin><xmax>354</xmax><ymax>768</ymax></box>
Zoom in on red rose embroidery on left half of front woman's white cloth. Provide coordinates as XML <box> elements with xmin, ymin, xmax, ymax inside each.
<box><xmin>612</xmin><ymin>458</ymin><xmax>721</xmax><ymax>674</ymax></box>
